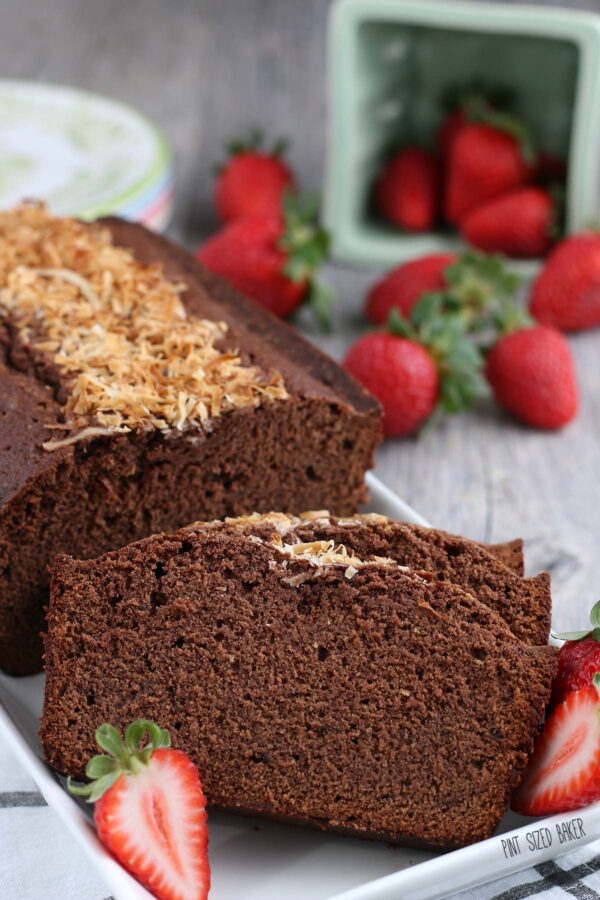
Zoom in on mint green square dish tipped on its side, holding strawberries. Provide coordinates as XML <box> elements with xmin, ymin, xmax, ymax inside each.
<box><xmin>325</xmin><ymin>0</ymin><xmax>600</xmax><ymax>266</ymax></box>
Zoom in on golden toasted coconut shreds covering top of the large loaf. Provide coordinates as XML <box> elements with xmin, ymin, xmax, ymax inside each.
<box><xmin>0</xmin><ymin>205</ymin><xmax>288</xmax><ymax>450</ymax></box>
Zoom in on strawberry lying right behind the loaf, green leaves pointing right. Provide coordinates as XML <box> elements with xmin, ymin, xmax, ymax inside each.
<box><xmin>197</xmin><ymin>196</ymin><xmax>330</xmax><ymax>326</ymax></box>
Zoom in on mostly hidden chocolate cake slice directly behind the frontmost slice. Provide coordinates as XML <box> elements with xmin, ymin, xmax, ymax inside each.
<box><xmin>198</xmin><ymin>510</ymin><xmax>552</xmax><ymax>644</ymax></box>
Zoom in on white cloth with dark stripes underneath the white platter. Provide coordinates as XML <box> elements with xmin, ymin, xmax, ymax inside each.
<box><xmin>0</xmin><ymin>747</ymin><xmax>600</xmax><ymax>900</ymax></box>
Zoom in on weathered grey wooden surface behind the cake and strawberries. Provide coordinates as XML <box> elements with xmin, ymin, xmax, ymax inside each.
<box><xmin>0</xmin><ymin>0</ymin><xmax>600</xmax><ymax>628</ymax></box>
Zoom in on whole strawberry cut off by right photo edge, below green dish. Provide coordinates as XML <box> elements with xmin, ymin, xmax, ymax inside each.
<box><xmin>529</xmin><ymin>231</ymin><xmax>600</xmax><ymax>331</ymax></box>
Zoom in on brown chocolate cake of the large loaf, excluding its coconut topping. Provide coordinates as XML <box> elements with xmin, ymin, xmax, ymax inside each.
<box><xmin>0</xmin><ymin>219</ymin><xmax>380</xmax><ymax>674</ymax></box>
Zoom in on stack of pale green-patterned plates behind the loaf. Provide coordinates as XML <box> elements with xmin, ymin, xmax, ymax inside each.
<box><xmin>0</xmin><ymin>80</ymin><xmax>173</xmax><ymax>231</ymax></box>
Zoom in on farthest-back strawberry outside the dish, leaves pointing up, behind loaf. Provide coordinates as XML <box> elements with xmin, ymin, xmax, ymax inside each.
<box><xmin>214</xmin><ymin>132</ymin><xmax>295</xmax><ymax>222</ymax></box>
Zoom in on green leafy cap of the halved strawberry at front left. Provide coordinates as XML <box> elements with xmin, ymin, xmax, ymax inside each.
<box><xmin>67</xmin><ymin>719</ymin><xmax>171</xmax><ymax>803</ymax></box>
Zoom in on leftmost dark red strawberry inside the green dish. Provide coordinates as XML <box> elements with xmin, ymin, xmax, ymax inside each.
<box><xmin>375</xmin><ymin>147</ymin><xmax>440</xmax><ymax>231</ymax></box>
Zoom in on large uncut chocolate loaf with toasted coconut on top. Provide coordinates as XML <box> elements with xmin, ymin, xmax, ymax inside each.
<box><xmin>0</xmin><ymin>206</ymin><xmax>380</xmax><ymax>674</ymax></box>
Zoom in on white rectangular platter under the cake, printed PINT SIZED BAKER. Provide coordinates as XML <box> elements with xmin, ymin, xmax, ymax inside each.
<box><xmin>0</xmin><ymin>475</ymin><xmax>600</xmax><ymax>900</ymax></box>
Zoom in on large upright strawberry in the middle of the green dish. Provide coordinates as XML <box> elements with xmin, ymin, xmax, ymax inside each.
<box><xmin>444</xmin><ymin>124</ymin><xmax>533</xmax><ymax>224</ymax></box>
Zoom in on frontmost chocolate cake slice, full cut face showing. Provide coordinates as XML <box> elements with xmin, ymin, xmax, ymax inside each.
<box><xmin>41</xmin><ymin>528</ymin><xmax>555</xmax><ymax>848</ymax></box>
